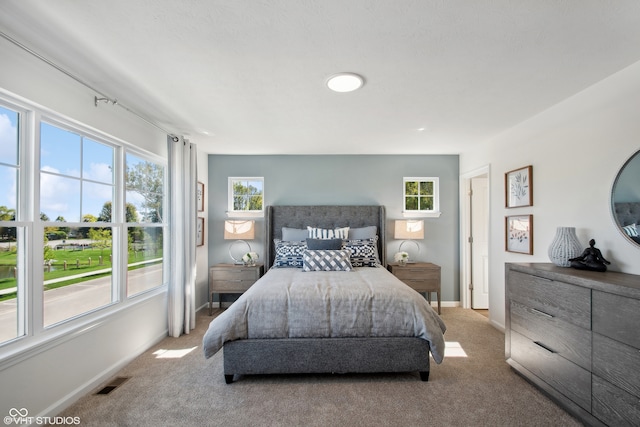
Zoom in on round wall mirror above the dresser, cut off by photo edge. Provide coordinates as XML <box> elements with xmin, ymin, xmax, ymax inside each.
<box><xmin>611</xmin><ymin>151</ymin><xmax>640</xmax><ymax>246</ymax></box>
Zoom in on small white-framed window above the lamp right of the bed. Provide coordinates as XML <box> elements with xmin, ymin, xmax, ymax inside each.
<box><xmin>403</xmin><ymin>177</ymin><xmax>440</xmax><ymax>216</ymax></box>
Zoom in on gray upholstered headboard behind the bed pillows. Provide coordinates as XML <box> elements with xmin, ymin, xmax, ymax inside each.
<box><xmin>264</xmin><ymin>205</ymin><xmax>387</xmax><ymax>271</ymax></box>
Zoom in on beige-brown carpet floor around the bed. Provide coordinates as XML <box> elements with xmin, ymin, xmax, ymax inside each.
<box><xmin>59</xmin><ymin>308</ymin><xmax>581</xmax><ymax>427</ymax></box>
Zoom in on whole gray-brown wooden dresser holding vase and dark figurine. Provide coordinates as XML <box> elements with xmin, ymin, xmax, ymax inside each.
<box><xmin>505</xmin><ymin>263</ymin><xmax>640</xmax><ymax>426</ymax></box>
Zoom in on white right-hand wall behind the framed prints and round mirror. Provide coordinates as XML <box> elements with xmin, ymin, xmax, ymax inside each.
<box><xmin>460</xmin><ymin>58</ymin><xmax>640</xmax><ymax>327</ymax></box>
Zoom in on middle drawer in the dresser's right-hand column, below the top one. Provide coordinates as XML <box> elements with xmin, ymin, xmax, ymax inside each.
<box><xmin>592</xmin><ymin>333</ymin><xmax>640</xmax><ymax>398</ymax></box>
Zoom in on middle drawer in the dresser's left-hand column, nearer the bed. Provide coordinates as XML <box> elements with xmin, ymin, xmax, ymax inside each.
<box><xmin>511</xmin><ymin>301</ymin><xmax>591</xmax><ymax>370</ymax></box>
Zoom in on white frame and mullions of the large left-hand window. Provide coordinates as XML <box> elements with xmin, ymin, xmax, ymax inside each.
<box><xmin>0</xmin><ymin>89</ymin><xmax>170</xmax><ymax>362</ymax></box>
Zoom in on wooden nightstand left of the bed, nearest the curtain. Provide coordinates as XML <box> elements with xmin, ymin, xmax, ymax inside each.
<box><xmin>209</xmin><ymin>264</ymin><xmax>263</xmax><ymax>316</ymax></box>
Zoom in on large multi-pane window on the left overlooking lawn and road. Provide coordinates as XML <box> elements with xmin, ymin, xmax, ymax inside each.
<box><xmin>0</xmin><ymin>94</ymin><xmax>167</xmax><ymax>346</ymax></box>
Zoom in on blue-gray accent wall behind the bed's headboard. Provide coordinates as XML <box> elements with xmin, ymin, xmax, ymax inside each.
<box><xmin>205</xmin><ymin>154</ymin><xmax>460</xmax><ymax>301</ymax></box>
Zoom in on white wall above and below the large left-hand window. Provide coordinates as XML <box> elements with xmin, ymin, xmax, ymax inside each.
<box><xmin>0</xmin><ymin>38</ymin><xmax>170</xmax><ymax>417</ymax></box>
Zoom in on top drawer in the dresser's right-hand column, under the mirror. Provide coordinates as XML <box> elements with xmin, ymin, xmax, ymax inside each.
<box><xmin>593</xmin><ymin>291</ymin><xmax>640</xmax><ymax>349</ymax></box>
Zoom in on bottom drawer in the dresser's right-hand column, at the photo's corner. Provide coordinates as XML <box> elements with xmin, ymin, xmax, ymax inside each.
<box><xmin>592</xmin><ymin>375</ymin><xmax>640</xmax><ymax>426</ymax></box>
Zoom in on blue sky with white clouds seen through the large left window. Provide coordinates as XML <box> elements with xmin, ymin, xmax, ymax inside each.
<box><xmin>0</xmin><ymin>106</ymin><xmax>158</xmax><ymax>222</ymax></box>
